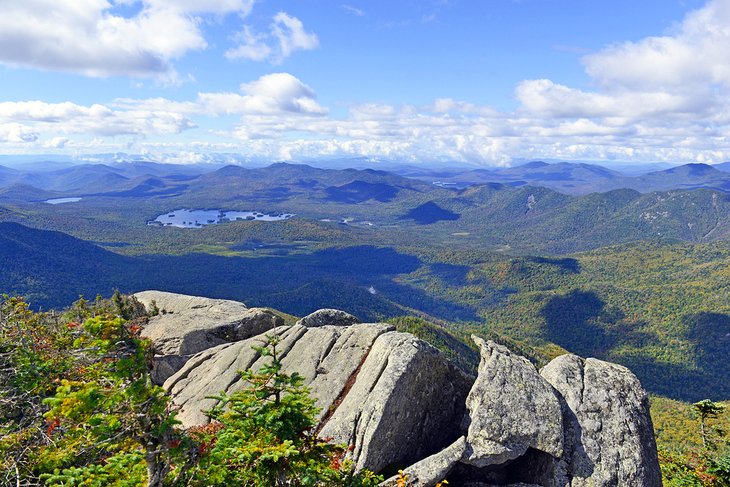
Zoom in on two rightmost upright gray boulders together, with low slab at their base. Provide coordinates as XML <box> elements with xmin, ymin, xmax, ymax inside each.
<box><xmin>381</xmin><ymin>337</ymin><xmax>661</xmax><ymax>487</ymax></box>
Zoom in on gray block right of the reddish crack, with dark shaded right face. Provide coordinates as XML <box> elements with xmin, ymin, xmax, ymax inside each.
<box><xmin>320</xmin><ymin>332</ymin><xmax>473</xmax><ymax>472</ymax></box>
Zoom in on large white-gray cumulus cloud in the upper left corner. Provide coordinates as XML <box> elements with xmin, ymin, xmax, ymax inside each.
<box><xmin>0</xmin><ymin>0</ymin><xmax>253</xmax><ymax>78</ymax></box>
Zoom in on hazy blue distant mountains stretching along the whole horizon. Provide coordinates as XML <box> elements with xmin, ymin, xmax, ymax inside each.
<box><xmin>7</xmin><ymin>159</ymin><xmax>730</xmax><ymax>196</ymax></box>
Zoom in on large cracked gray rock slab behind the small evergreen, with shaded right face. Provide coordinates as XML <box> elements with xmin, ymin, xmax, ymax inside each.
<box><xmin>164</xmin><ymin>324</ymin><xmax>473</xmax><ymax>471</ymax></box>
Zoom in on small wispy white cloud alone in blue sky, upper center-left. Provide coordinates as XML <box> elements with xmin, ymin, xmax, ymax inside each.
<box><xmin>226</xmin><ymin>12</ymin><xmax>319</xmax><ymax>64</ymax></box>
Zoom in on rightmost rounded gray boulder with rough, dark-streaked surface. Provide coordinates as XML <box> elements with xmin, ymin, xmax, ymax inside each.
<box><xmin>540</xmin><ymin>355</ymin><xmax>661</xmax><ymax>487</ymax></box>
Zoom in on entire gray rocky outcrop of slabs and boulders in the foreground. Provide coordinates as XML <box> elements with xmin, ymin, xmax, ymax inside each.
<box><xmin>135</xmin><ymin>292</ymin><xmax>661</xmax><ymax>487</ymax></box>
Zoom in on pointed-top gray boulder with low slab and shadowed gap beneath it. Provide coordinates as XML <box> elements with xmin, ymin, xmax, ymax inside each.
<box><xmin>382</xmin><ymin>336</ymin><xmax>564</xmax><ymax>487</ymax></box>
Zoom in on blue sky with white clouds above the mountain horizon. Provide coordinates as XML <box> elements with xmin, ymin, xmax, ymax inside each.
<box><xmin>0</xmin><ymin>0</ymin><xmax>730</xmax><ymax>166</ymax></box>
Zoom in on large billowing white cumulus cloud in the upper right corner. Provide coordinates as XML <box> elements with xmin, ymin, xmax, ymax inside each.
<box><xmin>516</xmin><ymin>0</ymin><xmax>730</xmax><ymax>123</ymax></box>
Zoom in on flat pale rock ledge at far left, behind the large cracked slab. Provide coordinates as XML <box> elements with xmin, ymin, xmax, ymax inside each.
<box><xmin>134</xmin><ymin>291</ymin><xmax>284</xmax><ymax>384</ymax></box>
